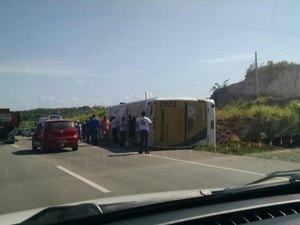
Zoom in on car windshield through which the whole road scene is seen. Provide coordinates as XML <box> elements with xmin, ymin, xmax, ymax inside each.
<box><xmin>0</xmin><ymin>0</ymin><xmax>300</xmax><ymax>223</ymax></box>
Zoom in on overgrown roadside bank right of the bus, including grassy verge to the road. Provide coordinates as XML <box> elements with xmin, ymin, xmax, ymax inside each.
<box><xmin>197</xmin><ymin>97</ymin><xmax>300</xmax><ymax>162</ymax></box>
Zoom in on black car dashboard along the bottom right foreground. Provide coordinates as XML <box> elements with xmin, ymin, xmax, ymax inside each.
<box><xmin>19</xmin><ymin>180</ymin><xmax>300</xmax><ymax>225</ymax></box>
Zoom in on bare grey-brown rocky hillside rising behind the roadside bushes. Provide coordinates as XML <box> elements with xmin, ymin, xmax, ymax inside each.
<box><xmin>211</xmin><ymin>64</ymin><xmax>300</xmax><ymax>106</ymax></box>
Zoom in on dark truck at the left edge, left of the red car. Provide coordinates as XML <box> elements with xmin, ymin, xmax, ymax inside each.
<box><xmin>0</xmin><ymin>108</ymin><xmax>20</xmax><ymax>144</ymax></box>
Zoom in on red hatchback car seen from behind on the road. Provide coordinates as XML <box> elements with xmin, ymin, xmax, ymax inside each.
<box><xmin>32</xmin><ymin>119</ymin><xmax>78</xmax><ymax>151</ymax></box>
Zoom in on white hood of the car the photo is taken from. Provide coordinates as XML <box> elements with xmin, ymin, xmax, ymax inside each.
<box><xmin>0</xmin><ymin>188</ymin><xmax>217</xmax><ymax>225</ymax></box>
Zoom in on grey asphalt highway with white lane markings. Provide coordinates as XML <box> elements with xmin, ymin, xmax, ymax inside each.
<box><xmin>0</xmin><ymin>137</ymin><xmax>300</xmax><ymax>215</ymax></box>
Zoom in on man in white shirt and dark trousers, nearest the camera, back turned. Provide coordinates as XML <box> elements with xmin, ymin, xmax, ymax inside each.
<box><xmin>136</xmin><ymin>111</ymin><xmax>152</xmax><ymax>154</ymax></box>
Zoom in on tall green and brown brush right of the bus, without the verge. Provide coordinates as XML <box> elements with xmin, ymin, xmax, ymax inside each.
<box><xmin>216</xmin><ymin>97</ymin><xmax>300</xmax><ymax>146</ymax></box>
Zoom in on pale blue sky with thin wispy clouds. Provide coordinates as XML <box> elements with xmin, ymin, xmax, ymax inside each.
<box><xmin>0</xmin><ymin>0</ymin><xmax>300</xmax><ymax>110</ymax></box>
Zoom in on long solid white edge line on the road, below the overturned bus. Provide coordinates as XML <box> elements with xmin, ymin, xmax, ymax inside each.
<box><xmin>145</xmin><ymin>154</ymin><xmax>266</xmax><ymax>177</ymax></box>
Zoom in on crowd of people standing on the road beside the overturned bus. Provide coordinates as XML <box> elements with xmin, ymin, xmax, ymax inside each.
<box><xmin>74</xmin><ymin>111</ymin><xmax>152</xmax><ymax>153</ymax></box>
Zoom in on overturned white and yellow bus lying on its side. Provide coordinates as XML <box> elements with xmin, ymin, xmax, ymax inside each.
<box><xmin>107</xmin><ymin>97</ymin><xmax>216</xmax><ymax>148</ymax></box>
